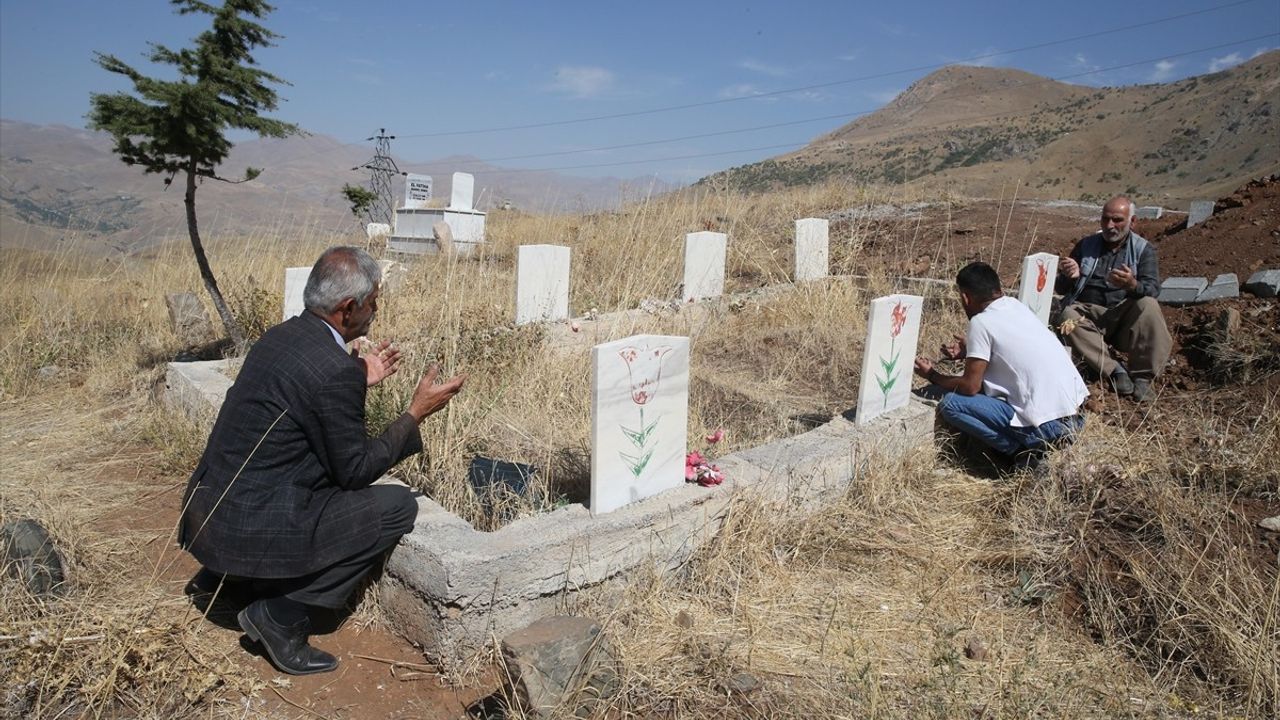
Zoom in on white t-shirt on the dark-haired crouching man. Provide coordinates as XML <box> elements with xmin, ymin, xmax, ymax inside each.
<box><xmin>965</xmin><ymin>296</ymin><xmax>1089</xmax><ymax>428</ymax></box>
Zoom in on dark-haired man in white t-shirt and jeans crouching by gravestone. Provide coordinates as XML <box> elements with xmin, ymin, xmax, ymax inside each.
<box><xmin>915</xmin><ymin>263</ymin><xmax>1089</xmax><ymax>468</ymax></box>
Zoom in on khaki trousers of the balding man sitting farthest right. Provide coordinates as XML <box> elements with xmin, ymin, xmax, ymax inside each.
<box><xmin>1061</xmin><ymin>297</ymin><xmax>1174</xmax><ymax>379</ymax></box>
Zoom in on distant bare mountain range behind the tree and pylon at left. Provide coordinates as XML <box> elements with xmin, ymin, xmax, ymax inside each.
<box><xmin>0</xmin><ymin>120</ymin><xmax>671</xmax><ymax>252</ymax></box>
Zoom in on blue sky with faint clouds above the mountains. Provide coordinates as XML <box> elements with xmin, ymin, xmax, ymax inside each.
<box><xmin>0</xmin><ymin>0</ymin><xmax>1280</xmax><ymax>182</ymax></box>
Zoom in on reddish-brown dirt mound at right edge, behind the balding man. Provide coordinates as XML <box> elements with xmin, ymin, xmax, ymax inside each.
<box><xmin>1147</xmin><ymin>176</ymin><xmax>1280</xmax><ymax>283</ymax></box>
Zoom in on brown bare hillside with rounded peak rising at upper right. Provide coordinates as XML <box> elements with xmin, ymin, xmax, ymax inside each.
<box><xmin>700</xmin><ymin>51</ymin><xmax>1280</xmax><ymax>204</ymax></box>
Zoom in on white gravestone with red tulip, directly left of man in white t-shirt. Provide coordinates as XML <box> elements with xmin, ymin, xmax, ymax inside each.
<box><xmin>855</xmin><ymin>295</ymin><xmax>924</xmax><ymax>425</ymax></box>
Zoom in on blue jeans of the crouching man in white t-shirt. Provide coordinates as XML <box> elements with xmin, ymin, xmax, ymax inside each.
<box><xmin>938</xmin><ymin>392</ymin><xmax>1084</xmax><ymax>455</ymax></box>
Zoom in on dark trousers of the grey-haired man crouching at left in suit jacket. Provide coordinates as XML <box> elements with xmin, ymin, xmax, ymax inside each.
<box><xmin>246</xmin><ymin>486</ymin><xmax>417</xmax><ymax>610</ymax></box>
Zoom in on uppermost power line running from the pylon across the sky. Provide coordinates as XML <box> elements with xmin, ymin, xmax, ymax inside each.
<box><xmin>389</xmin><ymin>0</ymin><xmax>1257</xmax><ymax>140</ymax></box>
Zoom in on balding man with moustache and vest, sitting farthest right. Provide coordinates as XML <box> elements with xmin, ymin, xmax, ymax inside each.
<box><xmin>1055</xmin><ymin>196</ymin><xmax>1174</xmax><ymax>402</ymax></box>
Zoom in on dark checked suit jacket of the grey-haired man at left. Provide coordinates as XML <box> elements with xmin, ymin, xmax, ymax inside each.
<box><xmin>178</xmin><ymin>313</ymin><xmax>422</xmax><ymax>578</ymax></box>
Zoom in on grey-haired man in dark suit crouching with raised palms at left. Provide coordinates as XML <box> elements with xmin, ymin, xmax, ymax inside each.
<box><xmin>179</xmin><ymin>247</ymin><xmax>463</xmax><ymax>675</ymax></box>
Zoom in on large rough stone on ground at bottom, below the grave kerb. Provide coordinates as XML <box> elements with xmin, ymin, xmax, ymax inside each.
<box><xmin>502</xmin><ymin>615</ymin><xmax>618</xmax><ymax>719</ymax></box>
